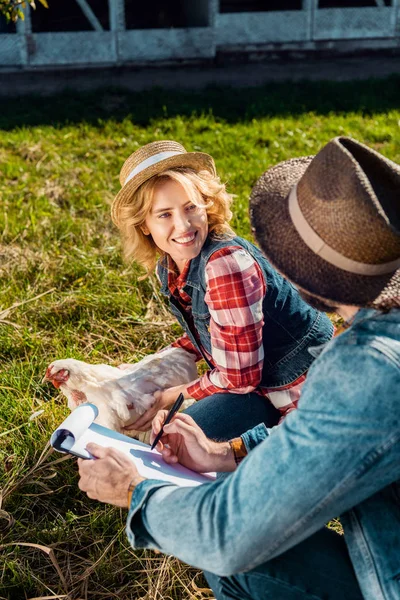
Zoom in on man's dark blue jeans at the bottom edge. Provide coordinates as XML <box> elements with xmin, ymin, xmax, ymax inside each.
<box><xmin>205</xmin><ymin>528</ymin><xmax>363</xmax><ymax>600</ymax></box>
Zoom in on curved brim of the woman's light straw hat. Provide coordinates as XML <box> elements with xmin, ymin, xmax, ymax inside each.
<box><xmin>111</xmin><ymin>152</ymin><xmax>216</xmax><ymax>227</ymax></box>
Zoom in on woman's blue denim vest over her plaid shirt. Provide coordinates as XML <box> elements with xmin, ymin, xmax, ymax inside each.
<box><xmin>157</xmin><ymin>237</ymin><xmax>333</xmax><ymax>389</ymax></box>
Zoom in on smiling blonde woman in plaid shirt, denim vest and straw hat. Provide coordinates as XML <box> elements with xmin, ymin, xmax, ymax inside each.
<box><xmin>112</xmin><ymin>141</ymin><xmax>333</xmax><ymax>439</ymax></box>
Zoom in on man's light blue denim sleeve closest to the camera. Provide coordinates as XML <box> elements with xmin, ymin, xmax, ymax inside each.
<box><xmin>127</xmin><ymin>338</ymin><xmax>400</xmax><ymax>576</ymax></box>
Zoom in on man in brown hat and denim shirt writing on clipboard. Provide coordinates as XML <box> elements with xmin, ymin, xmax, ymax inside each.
<box><xmin>79</xmin><ymin>137</ymin><xmax>400</xmax><ymax>600</ymax></box>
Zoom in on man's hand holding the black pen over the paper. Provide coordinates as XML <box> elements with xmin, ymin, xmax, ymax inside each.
<box><xmin>151</xmin><ymin>410</ymin><xmax>236</xmax><ymax>473</ymax></box>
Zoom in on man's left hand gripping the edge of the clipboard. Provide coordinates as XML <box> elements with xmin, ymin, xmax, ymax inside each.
<box><xmin>78</xmin><ymin>444</ymin><xmax>144</xmax><ymax>508</ymax></box>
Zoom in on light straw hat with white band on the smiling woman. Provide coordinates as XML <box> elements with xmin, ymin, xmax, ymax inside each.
<box><xmin>111</xmin><ymin>140</ymin><xmax>216</xmax><ymax>226</ymax></box>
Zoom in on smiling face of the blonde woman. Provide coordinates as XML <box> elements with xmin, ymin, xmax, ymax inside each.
<box><xmin>142</xmin><ymin>179</ymin><xmax>208</xmax><ymax>273</ymax></box>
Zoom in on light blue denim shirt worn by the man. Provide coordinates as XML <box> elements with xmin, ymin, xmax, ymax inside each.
<box><xmin>126</xmin><ymin>309</ymin><xmax>400</xmax><ymax>600</ymax></box>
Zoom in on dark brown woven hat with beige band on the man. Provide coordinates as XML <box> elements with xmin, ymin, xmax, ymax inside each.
<box><xmin>250</xmin><ymin>137</ymin><xmax>400</xmax><ymax>307</ymax></box>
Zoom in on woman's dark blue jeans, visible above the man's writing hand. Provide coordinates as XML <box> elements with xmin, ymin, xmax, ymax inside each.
<box><xmin>185</xmin><ymin>392</ymin><xmax>280</xmax><ymax>441</ymax></box>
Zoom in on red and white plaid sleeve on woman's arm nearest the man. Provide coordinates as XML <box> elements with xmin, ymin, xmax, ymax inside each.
<box><xmin>188</xmin><ymin>247</ymin><xmax>266</xmax><ymax>400</ymax></box>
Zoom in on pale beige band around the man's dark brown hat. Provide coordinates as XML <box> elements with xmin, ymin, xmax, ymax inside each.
<box><xmin>289</xmin><ymin>184</ymin><xmax>400</xmax><ymax>275</ymax></box>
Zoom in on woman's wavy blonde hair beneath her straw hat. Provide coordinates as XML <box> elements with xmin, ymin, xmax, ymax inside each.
<box><xmin>118</xmin><ymin>168</ymin><xmax>235</xmax><ymax>274</ymax></box>
